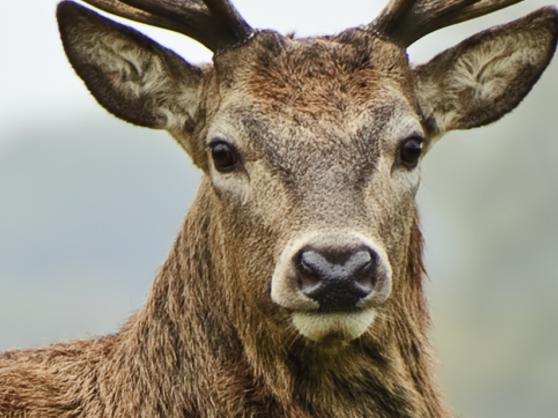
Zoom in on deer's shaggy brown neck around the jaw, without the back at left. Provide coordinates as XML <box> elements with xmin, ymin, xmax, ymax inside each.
<box><xmin>103</xmin><ymin>184</ymin><xmax>448</xmax><ymax>418</ymax></box>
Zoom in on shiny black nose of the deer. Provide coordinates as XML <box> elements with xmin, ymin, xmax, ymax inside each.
<box><xmin>295</xmin><ymin>246</ymin><xmax>378</xmax><ymax>312</ymax></box>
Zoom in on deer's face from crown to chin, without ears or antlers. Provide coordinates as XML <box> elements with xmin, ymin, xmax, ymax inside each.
<box><xmin>195</xmin><ymin>33</ymin><xmax>427</xmax><ymax>341</ymax></box>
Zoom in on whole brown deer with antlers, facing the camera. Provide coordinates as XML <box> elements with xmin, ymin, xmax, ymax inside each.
<box><xmin>0</xmin><ymin>0</ymin><xmax>558</xmax><ymax>418</ymax></box>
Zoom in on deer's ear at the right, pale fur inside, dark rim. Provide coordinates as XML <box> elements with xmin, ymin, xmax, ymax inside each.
<box><xmin>415</xmin><ymin>7</ymin><xmax>558</xmax><ymax>134</ymax></box>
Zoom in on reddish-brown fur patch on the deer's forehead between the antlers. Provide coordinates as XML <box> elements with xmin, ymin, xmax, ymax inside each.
<box><xmin>215</xmin><ymin>31</ymin><xmax>415</xmax><ymax>114</ymax></box>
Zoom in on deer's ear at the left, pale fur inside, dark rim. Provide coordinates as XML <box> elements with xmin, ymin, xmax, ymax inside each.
<box><xmin>57</xmin><ymin>1</ymin><xmax>202</xmax><ymax>130</ymax></box>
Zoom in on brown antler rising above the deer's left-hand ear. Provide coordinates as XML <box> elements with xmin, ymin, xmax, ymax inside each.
<box><xmin>79</xmin><ymin>0</ymin><xmax>253</xmax><ymax>51</ymax></box>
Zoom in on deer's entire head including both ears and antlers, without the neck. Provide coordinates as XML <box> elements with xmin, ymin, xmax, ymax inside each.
<box><xmin>58</xmin><ymin>0</ymin><xmax>558</xmax><ymax>344</ymax></box>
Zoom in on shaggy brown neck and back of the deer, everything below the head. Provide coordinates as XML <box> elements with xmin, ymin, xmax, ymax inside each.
<box><xmin>0</xmin><ymin>183</ymin><xmax>448</xmax><ymax>418</ymax></box>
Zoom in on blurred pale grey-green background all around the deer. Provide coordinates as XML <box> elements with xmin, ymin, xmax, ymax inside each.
<box><xmin>0</xmin><ymin>0</ymin><xmax>558</xmax><ymax>418</ymax></box>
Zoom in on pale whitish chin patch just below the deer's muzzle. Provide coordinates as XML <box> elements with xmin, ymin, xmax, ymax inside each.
<box><xmin>293</xmin><ymin>309</ymin><xmax>376</xmax><ymax>342</ymax></box>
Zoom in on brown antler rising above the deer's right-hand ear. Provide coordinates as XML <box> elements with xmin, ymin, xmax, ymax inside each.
<box><xmin>370</xmin><ymin>0</ymin><xmax>522</xmax><ymax>46</ymax></box>
